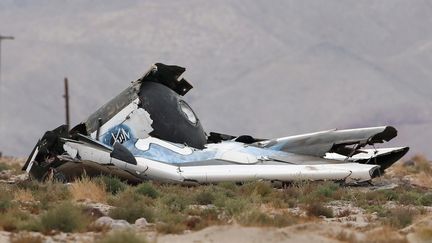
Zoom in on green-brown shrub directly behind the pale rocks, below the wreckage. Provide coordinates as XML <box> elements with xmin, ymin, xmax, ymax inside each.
<box><xmin>109</xmin><ymin>189</ymin><xmax>154</xmax><ymax>223</ymax></box>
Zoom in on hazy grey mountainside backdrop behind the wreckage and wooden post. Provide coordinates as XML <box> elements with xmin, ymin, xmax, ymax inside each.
<box><xmin>0</xmin><ymin>0</ymin><xmax>432</xmax><ymax>156</ymax></box>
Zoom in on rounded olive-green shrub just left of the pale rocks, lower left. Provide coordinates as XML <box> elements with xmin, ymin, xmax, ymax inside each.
<box><xmin>40</xmin><ymin>202</ymin><xmax>90</xmax><ymax>232</ymax></box>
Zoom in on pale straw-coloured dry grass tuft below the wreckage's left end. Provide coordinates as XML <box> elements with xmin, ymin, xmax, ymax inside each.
<box><xmin>69</xmin><ymin>177</ymin><xmax>107</xmax><ymax>203</ymax></box>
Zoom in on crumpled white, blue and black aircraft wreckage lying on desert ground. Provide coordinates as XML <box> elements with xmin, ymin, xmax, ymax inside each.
<box><xmin>23</xmin><ymin>63</ymin><xmax>409</xmax><ymax>183</ymax></box>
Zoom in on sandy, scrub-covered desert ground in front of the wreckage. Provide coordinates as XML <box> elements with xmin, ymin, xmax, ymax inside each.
<box><xmin>0</xmin><ymin>155</ymin><xmax>432</xmax><ymax>242</ymax></box>
